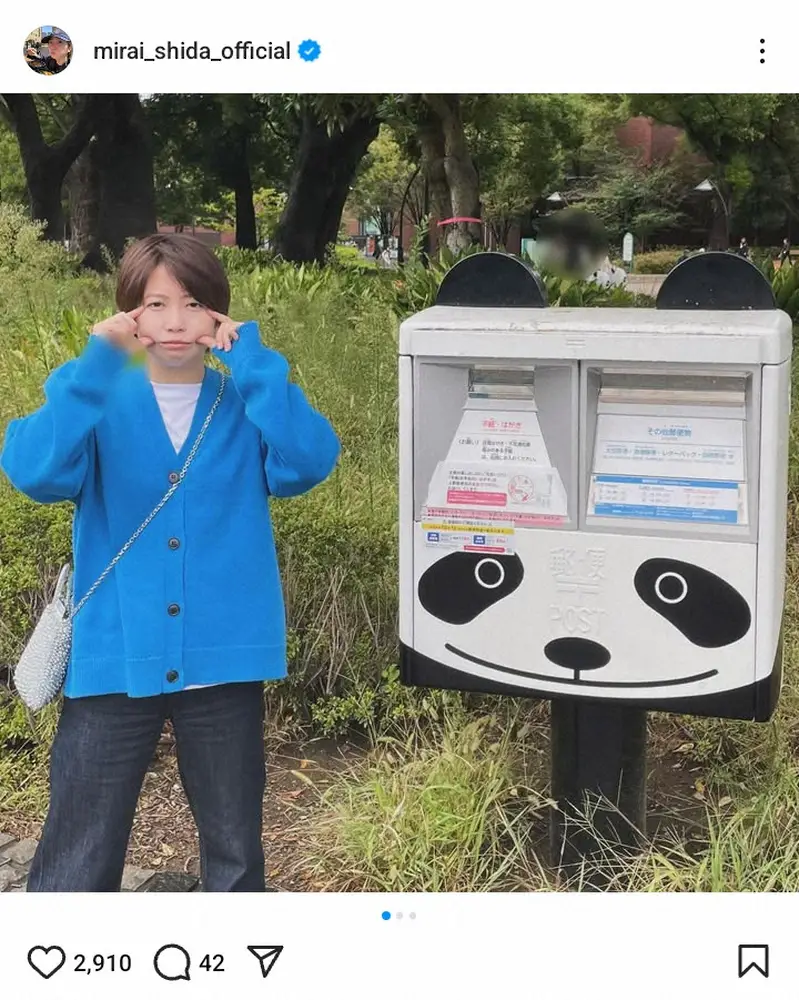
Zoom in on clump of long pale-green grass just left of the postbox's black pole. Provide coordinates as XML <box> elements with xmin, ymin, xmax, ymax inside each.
<box><xmin>288</xmin><ymin>707</ymin><xmax>548</xmax><ymax>892</ymax></box>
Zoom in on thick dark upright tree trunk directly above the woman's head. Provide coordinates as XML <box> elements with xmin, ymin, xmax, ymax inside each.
<box><xmin>82</xmin><ymin>94</ymin><xmax>157</xmax><ymax>271</ymax></box>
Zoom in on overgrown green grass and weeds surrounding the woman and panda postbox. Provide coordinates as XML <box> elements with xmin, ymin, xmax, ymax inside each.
<box><xmin>0</xmin><ymin>242</ymin><xmax>799</xmax><ymax>891</ymax></box>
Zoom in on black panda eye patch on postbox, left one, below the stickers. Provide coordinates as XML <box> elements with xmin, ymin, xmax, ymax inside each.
<box><xmin>419</xmin><ymin>552</ymin><xmax>524</xmax><ymax>625</ymax></box>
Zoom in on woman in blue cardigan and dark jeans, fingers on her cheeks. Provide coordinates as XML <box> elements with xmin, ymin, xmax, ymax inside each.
<box><xmin>0</xmin><ymin>234</ymin><xmax>339</xmax><ymax>892</ymax></box>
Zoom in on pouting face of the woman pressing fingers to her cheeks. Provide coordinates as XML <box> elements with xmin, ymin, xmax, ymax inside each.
<box><xmin>137</xmin><ymin>264</ymin><xmax>216</xmax><ymax>368</ymax></box>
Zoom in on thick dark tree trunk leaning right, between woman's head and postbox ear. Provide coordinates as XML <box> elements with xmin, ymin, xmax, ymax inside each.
<box><xmin>275</xmin><ymin>111</ymin><xmax>380</xmax><ymax>264</ymax></box>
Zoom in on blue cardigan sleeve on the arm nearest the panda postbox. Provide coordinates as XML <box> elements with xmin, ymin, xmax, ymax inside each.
<box><xmin>214</xmin><ymin>322</ymin><xmax>340</xmax><ymax>497</ymax></box>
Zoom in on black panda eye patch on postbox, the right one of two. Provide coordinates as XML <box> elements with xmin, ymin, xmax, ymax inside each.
<box><xmin>634</xmin><ymin>559</ymin><xmax>752</xmax><ymax>649</ymax></box>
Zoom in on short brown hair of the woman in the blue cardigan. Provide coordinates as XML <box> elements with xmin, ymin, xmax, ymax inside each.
<box><xmin>116</xmin><ymin>233</ymin><xmax>230</xmax><ymax>315</ymax></box>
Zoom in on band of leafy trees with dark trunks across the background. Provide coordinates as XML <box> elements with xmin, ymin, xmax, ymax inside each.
<box><xmin>0</xmin><ymin>94</ymin><xmax>799</xmax><ymax>266</ymax></box>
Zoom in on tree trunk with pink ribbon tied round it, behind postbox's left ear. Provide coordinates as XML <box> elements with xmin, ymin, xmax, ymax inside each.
<box><xmin>423</xmin><ymin>94</ymin><xmax>482</xmax><ymax>253</ymax></box>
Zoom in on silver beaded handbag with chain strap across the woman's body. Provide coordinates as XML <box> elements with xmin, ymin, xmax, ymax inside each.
<box><xmin>14</xmin><ymin>375</ymin><xmax>227</xmax><ymax>712</ymax></box>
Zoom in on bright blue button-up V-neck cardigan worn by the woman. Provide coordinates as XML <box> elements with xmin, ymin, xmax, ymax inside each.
<box><xmin>0</xmin><ymin>322</ymin><xmax>339</xmax><ymax>698</ymax></box>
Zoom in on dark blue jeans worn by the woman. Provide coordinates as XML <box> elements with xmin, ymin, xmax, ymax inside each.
<box><xmin>28</xmin><ymin>681</ymin><xmax>266</xmax><ymax>892</ymax></box>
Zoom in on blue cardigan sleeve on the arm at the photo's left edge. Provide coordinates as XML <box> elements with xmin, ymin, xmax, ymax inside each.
<box><xmin>0</xmin><ymin>336</ymin><xmax>128</xmax><ymax>503</ymax></box>
